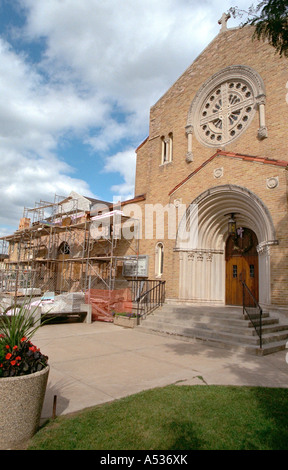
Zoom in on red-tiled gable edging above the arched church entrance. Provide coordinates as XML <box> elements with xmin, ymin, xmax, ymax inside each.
<box><xmin>169</xmin><ymin>150</ymin><xmax>288</xmax><ymax>196</ymax></box>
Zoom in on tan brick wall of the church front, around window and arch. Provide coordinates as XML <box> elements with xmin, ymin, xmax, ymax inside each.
<box><xmin>135</xmin><ymin>27</ymin><xmax>288</xmax><ymax>308</ymax></box>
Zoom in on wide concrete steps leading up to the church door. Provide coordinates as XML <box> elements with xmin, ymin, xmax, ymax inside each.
<box><xmin>138</xmin><ymin>304</ymin><xmax>288</xmax><ymax>355</ymax></box>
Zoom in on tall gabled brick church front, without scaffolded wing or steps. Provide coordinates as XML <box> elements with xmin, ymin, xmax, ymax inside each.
<box><xmin>135</xmin><ymin>15</ymin><xmax>288</xmax><ymax>315</ymax></box>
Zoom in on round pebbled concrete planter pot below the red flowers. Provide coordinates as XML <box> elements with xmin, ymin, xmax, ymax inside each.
<box><xmin>0</xmin><ymin>366</ymin><xmax>49</xmax><ymax>449</ymax></box>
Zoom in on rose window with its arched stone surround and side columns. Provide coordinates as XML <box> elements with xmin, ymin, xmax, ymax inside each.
<box><xmin>185</xmin><ymin>65</ymin><xmax>268</xmax><ymax>159</ymax></box>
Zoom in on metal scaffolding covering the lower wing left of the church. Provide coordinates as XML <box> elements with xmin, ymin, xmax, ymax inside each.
<box><xmin>0</xmin><ymin>195</ymin><xmax>139</xmax><ymax>295</ymax></box>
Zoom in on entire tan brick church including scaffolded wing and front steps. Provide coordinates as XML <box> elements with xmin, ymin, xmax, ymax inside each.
<box><xmin>0</xmin><ymin>15</ymin><xmax>288</xmax><ymax>354</ymax></box>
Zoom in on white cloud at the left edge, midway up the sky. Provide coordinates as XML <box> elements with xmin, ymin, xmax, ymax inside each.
<box><xmin>0</xmin><ymin>40</ymin><xmax>108</xmax><ymax>149</ymax></box>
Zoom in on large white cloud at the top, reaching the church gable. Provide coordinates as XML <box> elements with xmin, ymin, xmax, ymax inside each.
<box><xmin>22</xmin><ymin>0</ymin><xmax>218</xmax><ymax>112</ymax></box>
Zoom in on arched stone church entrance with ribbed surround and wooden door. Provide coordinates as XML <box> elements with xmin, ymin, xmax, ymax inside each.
<box><xmin>175</xmin><ymin>184</ymin><xmax>277</xmax><ymax>306</ymax></box>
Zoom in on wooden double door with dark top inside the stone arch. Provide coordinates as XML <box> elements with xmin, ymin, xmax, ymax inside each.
<box><xmin>225</xmin><ymin>228</ymin><xmax>259</xmax><ymax>305</ymax></box>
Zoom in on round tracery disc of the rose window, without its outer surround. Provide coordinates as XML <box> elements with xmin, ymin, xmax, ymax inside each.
<box><xmin>197</xmin><ymin>80</ymin><xmax>254</xmax><ymax>146</ymax></box>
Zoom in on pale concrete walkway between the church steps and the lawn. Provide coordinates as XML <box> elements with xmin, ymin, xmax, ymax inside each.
<box><xmin>32</xmin><ymin>322</ymin><xmax>288</xmax><ymax>420</ymax></box>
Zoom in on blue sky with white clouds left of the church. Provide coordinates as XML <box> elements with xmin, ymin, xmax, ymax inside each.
<box><xmin>0</xmin><ymin>0</ymin><xmax>251</xmax><ymax>236</ymax></box>
